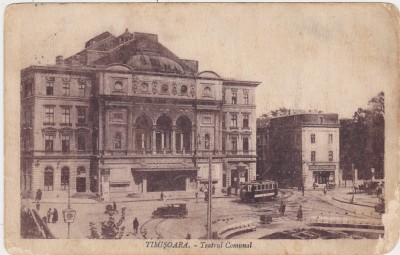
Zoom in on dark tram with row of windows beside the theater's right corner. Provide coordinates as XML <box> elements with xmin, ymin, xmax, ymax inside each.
<box><xmin>240</xmin><ymin>180</ymin><xmax>278</xmax><ymax>202</ymax></box>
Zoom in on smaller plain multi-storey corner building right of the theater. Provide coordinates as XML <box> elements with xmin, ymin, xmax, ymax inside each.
<box><xmin>257</xmin><ymin>112</ymin><xmax>340</xmax><ymax>187</ymax></box>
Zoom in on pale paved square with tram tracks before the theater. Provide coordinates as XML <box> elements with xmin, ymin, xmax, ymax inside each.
<box><xmin>26</xmin><ymin>189</ymin><xmax>379</xmax><ymax>239</ymax></box>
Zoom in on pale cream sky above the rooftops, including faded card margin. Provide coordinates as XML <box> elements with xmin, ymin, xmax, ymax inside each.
<box><xmin>5</xmin><ymin>3</ymin><xmax>398</xmax><ymax>118</ymax></box>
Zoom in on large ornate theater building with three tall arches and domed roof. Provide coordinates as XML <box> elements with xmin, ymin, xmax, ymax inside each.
<box><xmin>21</xmin><ymin>30</ymin><xmax>259</xmax><ymax>199</ymax></box>
